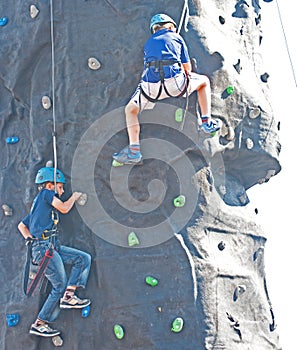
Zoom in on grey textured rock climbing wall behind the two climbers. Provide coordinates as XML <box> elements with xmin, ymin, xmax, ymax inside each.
<box><xmin>0</xmin><ymin>0</ymin><xmax>280</xmax><ymax>350</ymax></box>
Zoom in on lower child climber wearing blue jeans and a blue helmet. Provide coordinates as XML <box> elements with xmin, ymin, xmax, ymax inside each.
<box><xmin>18</xmin><ymin>167</ymin><xmax>91</xmax><ymax>337</ymax></box>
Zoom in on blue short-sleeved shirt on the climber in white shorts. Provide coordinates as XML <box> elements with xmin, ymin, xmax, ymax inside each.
<box><xmin>142</xmin><ymin>29</ymin><xmax>190</xmax><ymax>83</ymax></box>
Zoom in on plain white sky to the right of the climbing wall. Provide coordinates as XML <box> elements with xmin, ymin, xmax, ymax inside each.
<box><xmin>248</xmin><ymin>0</ymin><xmax>297</xmax><ymax>350</ymax></box>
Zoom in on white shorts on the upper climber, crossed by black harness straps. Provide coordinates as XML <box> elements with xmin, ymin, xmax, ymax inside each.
<box><xmin>129</xmin><ymin>72</ymin><xmax>203</xmax><ymax>110</ymax></box>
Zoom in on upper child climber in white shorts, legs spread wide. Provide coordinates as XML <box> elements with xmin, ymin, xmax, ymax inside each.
<box><xmin>113</xmin><ymin>14</ymin><xmax>221</xmax><ymax>164</ymax></box>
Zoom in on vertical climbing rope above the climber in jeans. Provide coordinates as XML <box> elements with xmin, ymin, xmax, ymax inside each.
<box><xmin>50</xmin><ymin>0</ymin><xmax>58</xmax><ymax>192</ymax></box>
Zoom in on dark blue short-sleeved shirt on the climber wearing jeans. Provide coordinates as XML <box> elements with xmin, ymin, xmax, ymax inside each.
<box><xmin>22</xmin><ymin>189</ymin><xmax>55</xmax><ymax>238</ymax></box>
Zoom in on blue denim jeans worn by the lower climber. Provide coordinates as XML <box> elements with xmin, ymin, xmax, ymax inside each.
<box><xmin>32</xmin><ymin>241</ymin><xmax>91</xmax><ymax>322</ymax></box>
